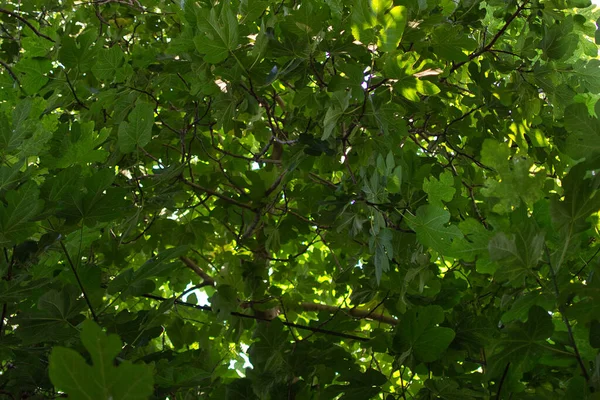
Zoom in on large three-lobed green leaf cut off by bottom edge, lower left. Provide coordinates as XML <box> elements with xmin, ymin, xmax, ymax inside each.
<box><xmin>50</xmin><ymin>320</ymin><xmax>153</xmax><ymax>400</ymax></box>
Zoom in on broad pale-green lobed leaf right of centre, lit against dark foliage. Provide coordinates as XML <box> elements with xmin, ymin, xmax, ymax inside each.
<box><xmin>405</xmin><ymin>205</ymin><xmax>463</xmax><ymax>252</ymax></box>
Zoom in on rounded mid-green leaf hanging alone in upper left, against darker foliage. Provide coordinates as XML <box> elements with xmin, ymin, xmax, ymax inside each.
<box><xmin>119</xmin><ymin>102</ymin><xmax>154</xmax><ymax>153</ymax></box>
